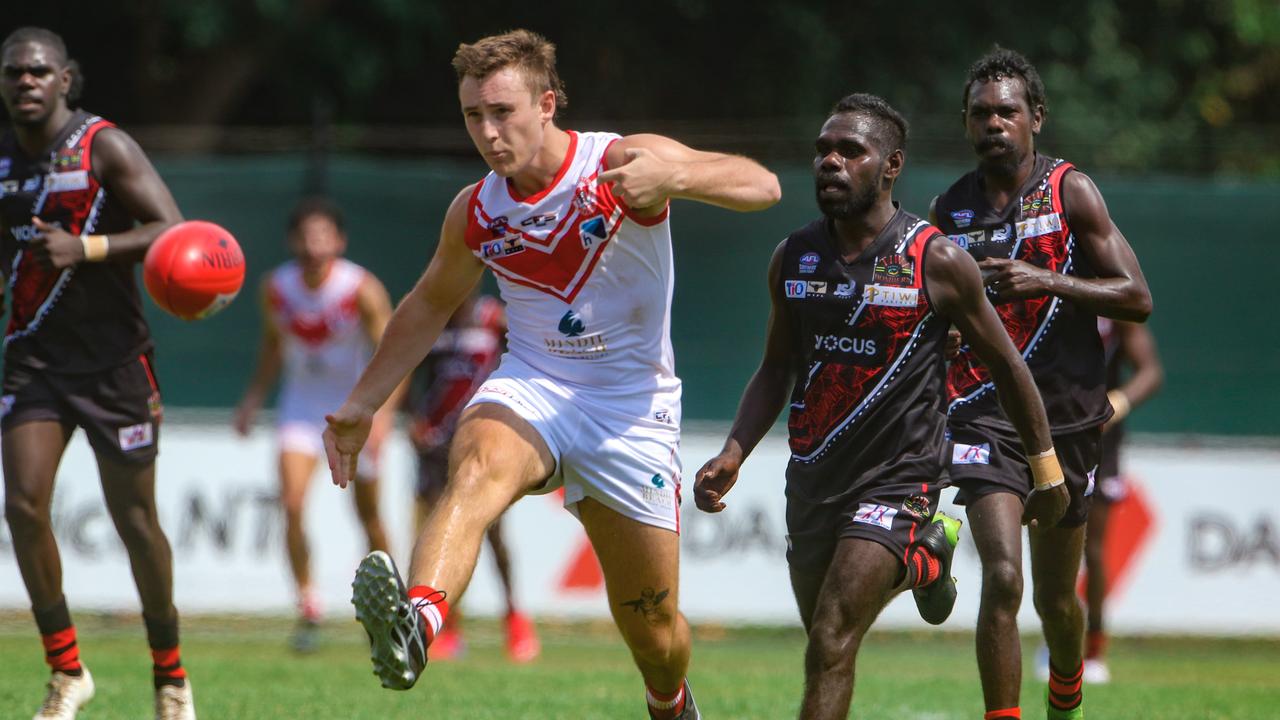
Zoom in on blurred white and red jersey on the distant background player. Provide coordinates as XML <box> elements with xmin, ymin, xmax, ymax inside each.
<box><xmin>268</xmin><ymin>258</ymin><xmax>372</xmax><ymax>421</ymax></box>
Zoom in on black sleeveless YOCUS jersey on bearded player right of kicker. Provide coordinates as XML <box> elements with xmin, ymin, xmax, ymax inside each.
<box><xmin>774</xmin><ymin>204</ymin><xmax>948</xmax><ymax>502</ymax></box>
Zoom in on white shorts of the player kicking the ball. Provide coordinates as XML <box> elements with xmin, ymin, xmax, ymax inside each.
<box><xmin>467</xmin><ymin>355</ymin><xmax>680</xmax><ymax>533</ymax></box>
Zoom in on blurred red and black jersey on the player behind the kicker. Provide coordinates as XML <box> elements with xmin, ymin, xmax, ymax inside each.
<box><xmin>404</xmin><ymin>296</ymin><xmax>507</xmax><ymax>452</ymax></box>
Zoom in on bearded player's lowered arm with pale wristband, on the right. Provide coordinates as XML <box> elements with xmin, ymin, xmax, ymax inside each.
<box><xmin>924</xmin><ymin>238</ymin><xmax>1071</xmax><ymax>527</ymax></box>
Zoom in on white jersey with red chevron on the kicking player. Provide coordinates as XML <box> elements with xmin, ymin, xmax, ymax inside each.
<box><xmin>466</xmin><ymin>131</ymin><xmax>680</xmax><ymax>393</ymax></box>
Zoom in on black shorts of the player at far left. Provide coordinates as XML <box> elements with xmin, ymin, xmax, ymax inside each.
<box><xmin>0</xmin><ymin>352</ymin><xmax>164</xmax><ymax>465</ymax></box>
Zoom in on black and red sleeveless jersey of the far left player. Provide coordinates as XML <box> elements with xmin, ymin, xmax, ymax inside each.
<box><xmin>0</xmin><ymin>110</ymin><xmax>151</xmax><ymax>373</ymax></box>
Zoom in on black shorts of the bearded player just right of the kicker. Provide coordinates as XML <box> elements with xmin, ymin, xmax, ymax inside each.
<box><xmin>787</xmin><ymin>480</ymin><xmax>940</xmax><ymax>573</ymax></box>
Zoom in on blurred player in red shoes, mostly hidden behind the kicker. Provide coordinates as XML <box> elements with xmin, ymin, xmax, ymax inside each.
<box><xmin>404</xmin><ymin>289</ymin><xmax>540</xmax><ymax>662</ymax></box>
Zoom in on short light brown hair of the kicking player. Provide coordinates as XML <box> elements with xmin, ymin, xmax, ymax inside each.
<box><xmin>453</xmin><ymin>29</ymin><xmax>568</xmax><ymax>110</ymax></box>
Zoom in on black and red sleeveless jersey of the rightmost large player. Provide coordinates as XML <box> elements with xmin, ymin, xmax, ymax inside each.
<box><xmin>934</xmin><ymin>155</ymin><xmax>1111</xmax><ymax>433</ymax></box>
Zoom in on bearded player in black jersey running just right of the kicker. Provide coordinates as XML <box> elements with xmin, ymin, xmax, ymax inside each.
<box><xmin>694</xmin><ymin>95</ymin><xmax>1065</xmax><ymax>719</ymax></box>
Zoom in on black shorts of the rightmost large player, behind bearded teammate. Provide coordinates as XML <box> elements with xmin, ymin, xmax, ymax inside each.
<box><xmin>947</xmin><ymin>423</ymin><xmax>1102</xmax><ymax>528</ymax></box>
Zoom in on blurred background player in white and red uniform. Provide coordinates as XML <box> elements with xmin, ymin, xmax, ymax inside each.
<box><xmin>234</xmin><ymin>199</ymin><xmax>392</xmax><ymax>652</ymax></box>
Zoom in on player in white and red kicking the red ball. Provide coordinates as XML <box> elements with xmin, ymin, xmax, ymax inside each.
<box><xmin>325</xmin><ymin>31</ymin><xmax>781</xmax><ymax>719</ymax></box>
